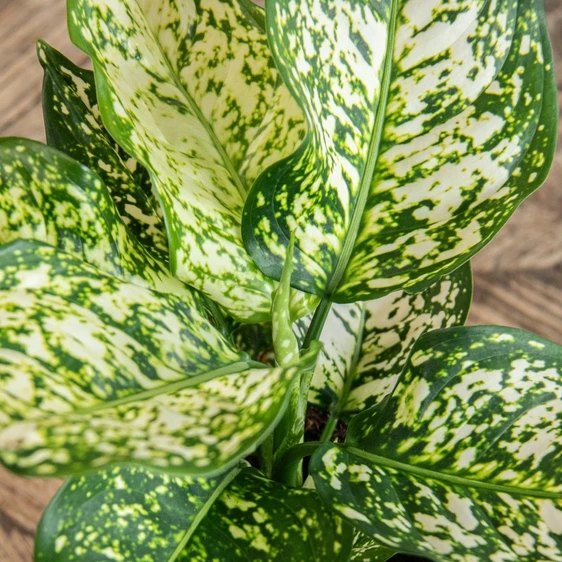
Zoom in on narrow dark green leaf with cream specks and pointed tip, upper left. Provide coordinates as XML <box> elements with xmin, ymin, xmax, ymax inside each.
<box><xmin>37</xmin><ymin>41</ymin><xmax>168</xmax><ymax>254</ymax></box>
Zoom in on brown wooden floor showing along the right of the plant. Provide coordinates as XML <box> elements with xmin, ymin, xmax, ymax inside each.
<box><xmin>470</xmin><ymin>0</ymin><xmax>562</xmax><ymax>336</ymax></box>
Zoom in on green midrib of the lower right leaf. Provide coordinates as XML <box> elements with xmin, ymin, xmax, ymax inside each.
<box><xmin>344</xmin><ymin>446</ymin><xmax>562</xmax><ymax>500</ymax></box>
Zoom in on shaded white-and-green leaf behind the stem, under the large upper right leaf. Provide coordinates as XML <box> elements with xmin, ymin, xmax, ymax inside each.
<box><xmin>297</xmin><ymin>264</ymin><xmax>472</xmax><ymax>415</ymax></box>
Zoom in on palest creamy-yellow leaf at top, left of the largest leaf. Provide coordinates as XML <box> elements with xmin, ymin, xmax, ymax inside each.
<box><xmin>68</xmin><ymin>0</ymin><xmax>304</xmax><ymax>322</ymax></box>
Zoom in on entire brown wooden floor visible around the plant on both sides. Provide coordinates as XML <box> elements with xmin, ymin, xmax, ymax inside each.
<box><xmin>0</xmin><ymin>0</ymin><xmax>562</xmax><ymax>562</ymax></box>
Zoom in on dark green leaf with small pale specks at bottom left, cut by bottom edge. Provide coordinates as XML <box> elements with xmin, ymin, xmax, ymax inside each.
<box><xmin>35</xmin><ymin>465</ymin><xmax>352</xmax><ymax>562</ymax></box>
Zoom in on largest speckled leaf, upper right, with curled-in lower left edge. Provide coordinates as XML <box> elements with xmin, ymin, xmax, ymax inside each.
<box><xmin>243</xmin><ymin>0</ymin><xmax>557</xmax><ymax>303</ymax></box>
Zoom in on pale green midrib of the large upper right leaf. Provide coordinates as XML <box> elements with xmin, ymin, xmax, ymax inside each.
<box><xmin>325</xmin><ymin>0</ymin><xmax>398</xmax><ymax>301</ymax></box>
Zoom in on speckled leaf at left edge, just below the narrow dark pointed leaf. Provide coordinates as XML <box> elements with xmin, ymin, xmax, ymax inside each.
<box><xmin>0</xmin><ymin>138</ymin><xmax>191</xmax><ymax>303</ymax></box>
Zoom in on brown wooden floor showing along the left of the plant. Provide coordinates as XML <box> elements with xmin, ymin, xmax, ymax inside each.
<box><xmin>0</xmin><ymin>0</ymin><xmax>72</xmax><ymax>562</ymax></box>
